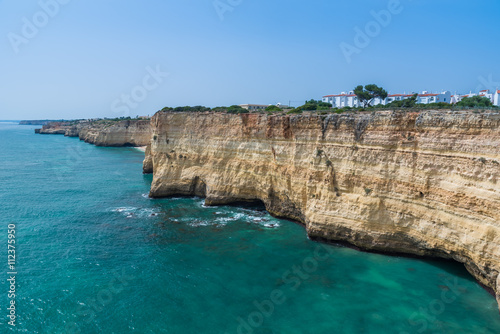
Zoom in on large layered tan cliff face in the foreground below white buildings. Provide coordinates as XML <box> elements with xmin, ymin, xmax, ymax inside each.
<box><xmin>145</xmin><ymin>111</ymin><xmax>500</xmax><ymax>308</ymax></box>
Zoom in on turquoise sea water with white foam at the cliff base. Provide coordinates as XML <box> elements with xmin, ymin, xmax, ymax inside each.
<box><xmin>0</xmin><ymin>123</ymin><xmax>500</xmax><ymax>334</ymax></box>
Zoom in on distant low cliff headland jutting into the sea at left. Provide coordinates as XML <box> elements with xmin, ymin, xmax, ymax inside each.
<box><xmin>38</xmin><ymin>120</ymin><xmax>151</xmax><ymax>146</ymax></box>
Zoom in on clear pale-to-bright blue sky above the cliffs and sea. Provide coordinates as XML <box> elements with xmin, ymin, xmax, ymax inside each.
<box><xmin>0</xmin><ymin>0</ymin><xmax>500</xmax><ymax>120</ymax></box>
